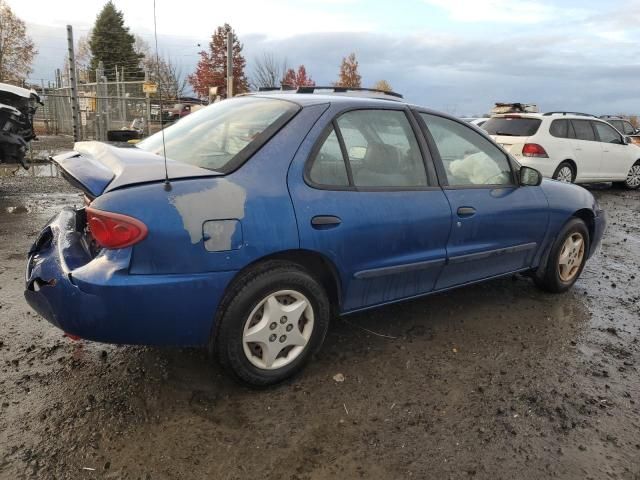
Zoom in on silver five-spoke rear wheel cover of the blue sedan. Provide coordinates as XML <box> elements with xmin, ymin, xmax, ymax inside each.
<box><xmin>242</xmin><ymin>290</ymin><xmax>314</xmax><ymax>370</ymax></box>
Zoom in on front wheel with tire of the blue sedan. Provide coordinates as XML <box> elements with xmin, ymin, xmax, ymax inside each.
<box><xmin>533</xmin><ymin>218</ymin><xmax>590</xmax><ymax>293</ymax></box>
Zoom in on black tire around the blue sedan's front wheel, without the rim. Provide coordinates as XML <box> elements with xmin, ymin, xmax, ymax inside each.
<box><xmin>533</xmin><ymin>218</ymin><xmax>591</xmax><ymax>293</ymax></box>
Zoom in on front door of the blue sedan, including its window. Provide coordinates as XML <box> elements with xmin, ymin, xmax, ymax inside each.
<box><xmin>419</xmin><ymin>113</ymin><xmax>548</xmax><ymax>289</ymax></box>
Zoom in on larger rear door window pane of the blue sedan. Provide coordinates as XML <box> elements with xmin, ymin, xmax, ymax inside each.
<box><xmin>336</xmin><ymin>110</ymin><xmax>427</xmax><ymax>187</ymax></box>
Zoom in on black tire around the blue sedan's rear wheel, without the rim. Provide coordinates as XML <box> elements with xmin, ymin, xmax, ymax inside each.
<box><xmin>211</xmin><ymin>260</ymin><xmax>331</xmax><ymax>388</ymax></box>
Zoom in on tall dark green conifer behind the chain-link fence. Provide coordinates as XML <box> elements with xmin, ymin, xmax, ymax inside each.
<box><xmin>89</xmin><ymin>0</ymin><xmax>144</xmax><ymax>81</ymax></box>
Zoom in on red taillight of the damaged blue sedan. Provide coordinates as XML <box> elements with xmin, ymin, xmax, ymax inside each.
<box><xmin>85</xmin><ymin>208</ymin><xmax>147</xmax><ymax>248</ymax></box>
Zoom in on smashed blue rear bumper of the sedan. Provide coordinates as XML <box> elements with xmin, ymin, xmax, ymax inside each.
<box><xmin>24</xmin><ymin>209</ymin><xmax>235</xmax><ymax>345</ymax></box>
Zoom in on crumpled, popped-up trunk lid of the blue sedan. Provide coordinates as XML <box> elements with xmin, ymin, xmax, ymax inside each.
<box><xmin>51</xmin><ymin>142</ymin><xmax>221</xmax><ymax>199</ymax></box>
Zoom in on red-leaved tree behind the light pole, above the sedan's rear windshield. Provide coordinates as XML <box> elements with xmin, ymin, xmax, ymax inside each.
<box><xmin>188</xmin><ymin>23</ymin><xmax>249</xmax><ymax>98</ymax></box>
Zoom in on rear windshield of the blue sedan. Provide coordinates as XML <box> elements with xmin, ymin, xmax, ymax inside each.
<box><xmin>137</xmin><ymin>97</ymin><xmax>300</xmax><ymax>173</ymax></box>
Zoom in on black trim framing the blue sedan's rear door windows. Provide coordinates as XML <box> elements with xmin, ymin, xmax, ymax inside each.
<box><xmin>303</xmin><ymin>105</ymin><xmax>440</xmax><ymax>192</ymax></box>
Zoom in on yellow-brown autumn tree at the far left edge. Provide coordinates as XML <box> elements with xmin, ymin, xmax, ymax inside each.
<box><xmin>0</xmin><ymin>0</ymin><xmax>38</xmax><ymax>85</ymax></box>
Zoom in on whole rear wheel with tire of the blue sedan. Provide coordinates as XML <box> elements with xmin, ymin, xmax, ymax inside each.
<box><xmin>213</xmin><ymin>261</ymin><xmax>330</xmax><ymax>387</ymax></box>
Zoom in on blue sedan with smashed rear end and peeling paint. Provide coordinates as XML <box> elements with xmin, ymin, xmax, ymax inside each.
<box><xmin>25</xmin><ymin>89</ymin><xmax>605</xmax><ymax>386</ymax></box>
